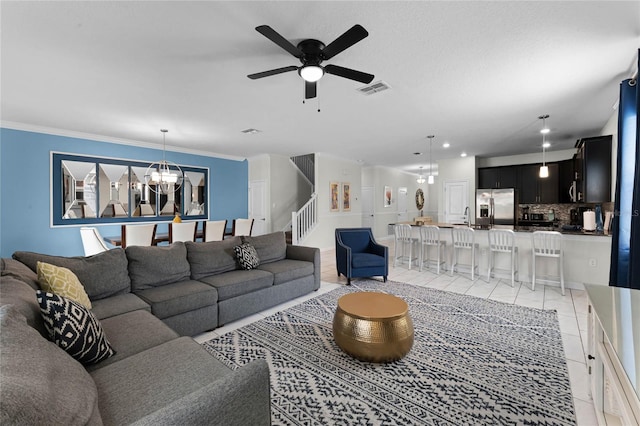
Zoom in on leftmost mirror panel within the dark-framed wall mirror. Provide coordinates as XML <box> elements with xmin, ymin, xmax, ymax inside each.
<box><xmin>62</xmin><ymin>160</ymin><xmax>97</xmax><ymax>219</ymax></box>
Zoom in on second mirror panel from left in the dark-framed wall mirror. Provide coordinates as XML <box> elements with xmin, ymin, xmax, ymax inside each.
<box><xmin>98</xmin><ymin>163</ymin><xmax>129</xmax><ymax>217</ymax></box>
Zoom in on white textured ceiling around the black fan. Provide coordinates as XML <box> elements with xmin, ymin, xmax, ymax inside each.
<box><xmin>0</xmin><ymin>1</ymin><xmax>640</xmax><ymax>172</ymax></box>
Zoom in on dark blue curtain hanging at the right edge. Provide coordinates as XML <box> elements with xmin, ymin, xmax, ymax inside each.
<box><xmin>609</xmin><ymin>50</ymin><xmax>640</xmax><ymax>289</ymax></box>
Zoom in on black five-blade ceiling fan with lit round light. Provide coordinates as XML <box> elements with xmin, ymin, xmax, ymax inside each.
<box><xmin>247</xmin><ymin>25</ymin><xmax>374</xmax><ymax>99</ymax></box>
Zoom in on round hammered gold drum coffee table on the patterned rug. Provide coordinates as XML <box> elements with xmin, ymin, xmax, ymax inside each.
<box><xmin>333</xmin><ymin>291</ymin><xmax>413</xmax><ymax>362</ymax></box>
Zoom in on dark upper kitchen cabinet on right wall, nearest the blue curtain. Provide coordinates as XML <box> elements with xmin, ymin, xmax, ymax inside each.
<box><xmin>575</xmin><ymin>135</ymin><xmax>612</xmax><ymax>203</ymax></box>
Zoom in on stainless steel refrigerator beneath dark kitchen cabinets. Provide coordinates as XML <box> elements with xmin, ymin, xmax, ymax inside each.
<box><xmin>476</xmin><ymin>188</ymin><xmax>518</xmax><ymax>226</ymax></box>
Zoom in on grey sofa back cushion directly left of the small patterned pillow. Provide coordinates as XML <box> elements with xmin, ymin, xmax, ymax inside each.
<box><xmin>185</xmin><ymin>237</ymin><xmax>242</xmax><ymax>280</ymax></box>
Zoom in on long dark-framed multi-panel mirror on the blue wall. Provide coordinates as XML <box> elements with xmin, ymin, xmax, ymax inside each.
<box><xmin>51</xmin><ymin>152</ymin><xmax>209</xmax><ymax>226</ymax></box>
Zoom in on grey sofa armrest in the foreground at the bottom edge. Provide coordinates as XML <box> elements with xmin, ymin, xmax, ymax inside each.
<box><xmin>134</xmin><ymin>360</ymin><xmax>271</xmax><ymax>426</ymax></box>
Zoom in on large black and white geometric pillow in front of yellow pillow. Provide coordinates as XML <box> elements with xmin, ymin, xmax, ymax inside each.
<box><xmin>36</xmin><ymin>290</ymin><xmax>116</xmax><ymax>364</ymax></box>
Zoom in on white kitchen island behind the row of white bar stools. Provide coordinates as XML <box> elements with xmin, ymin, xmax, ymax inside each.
<box><xmin>389</xmin><ymin>222</ymin><xmax>611</xmax><ymax>289</ymax></box>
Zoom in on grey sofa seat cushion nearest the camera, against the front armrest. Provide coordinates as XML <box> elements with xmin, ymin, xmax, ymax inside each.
<box><xmin>91</xmin><ymin>337</ymin><xmax>233</xmax><ymax>425</ymax></box>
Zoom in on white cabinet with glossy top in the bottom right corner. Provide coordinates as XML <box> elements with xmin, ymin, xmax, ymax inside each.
<box><xmin>585</xmin><ymin>285</ymin><xmax>640</xmax><ymax>426</ymax></box>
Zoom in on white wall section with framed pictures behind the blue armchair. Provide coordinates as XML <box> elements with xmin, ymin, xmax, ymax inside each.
<box><xmin>303</xmin><ymin>153</ymin><xmax>362</xmax><ymax>249</ymax></box>
